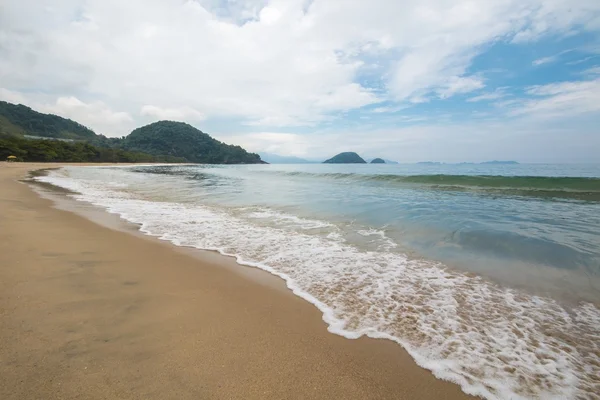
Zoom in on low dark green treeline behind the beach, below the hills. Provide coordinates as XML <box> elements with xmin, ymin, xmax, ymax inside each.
<box><xmin>0</xmin><ymin>134</ymin><xmax>186</xmax><ymax>163</ymax></box>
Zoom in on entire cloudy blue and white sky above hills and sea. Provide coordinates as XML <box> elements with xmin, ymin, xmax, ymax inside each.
<box><xmin>0</xmin><ymin>0</ymin><xmax>600</xmax><ymax>163</ymax></box>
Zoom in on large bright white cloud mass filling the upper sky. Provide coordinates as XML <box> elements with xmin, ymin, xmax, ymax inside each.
<box><xmin>0</xmin><ymin>0</ymin><xmax>600</xmax><ymax>138</ymax></box>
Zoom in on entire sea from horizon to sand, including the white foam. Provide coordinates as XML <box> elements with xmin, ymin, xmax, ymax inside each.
<box><xmin>37</xmin><ymin>164</ymin><xmax>600</xmax><ymax>399</ymax></box>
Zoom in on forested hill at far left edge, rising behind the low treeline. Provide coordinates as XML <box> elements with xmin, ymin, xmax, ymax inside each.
<box><xmin>0</xmin><ymin>101</ymin><xmax>96</xmax><ymax>141</ymax></box>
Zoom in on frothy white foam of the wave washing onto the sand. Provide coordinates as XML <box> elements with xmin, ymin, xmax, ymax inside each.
<box><xmin>38</xmin><ymin>171</ymin><xmax>600</xmax><ymax>399</ymax></box>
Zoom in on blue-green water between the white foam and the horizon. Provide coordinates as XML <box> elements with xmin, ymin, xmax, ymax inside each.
<box><xmin>135</xmin><ymin>164</ymin><xmax>600</xmax><ymax>301</ymax></box>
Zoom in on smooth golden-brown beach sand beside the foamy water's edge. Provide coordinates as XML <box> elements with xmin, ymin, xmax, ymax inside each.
<box><xmin>0</xmin><ymin>163</ymin><xmax>468</xmax><ymax>400</ymax></box>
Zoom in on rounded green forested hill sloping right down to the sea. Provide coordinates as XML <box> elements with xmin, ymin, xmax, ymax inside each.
<box><xmin>121</xmin><ymin>121</ymin><xmax>264</xmax><ymax>164</ymax></box>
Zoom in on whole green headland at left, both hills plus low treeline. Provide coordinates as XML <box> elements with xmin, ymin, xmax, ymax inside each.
<box><xmin>0</xmin><ymin>101</ymin><xmax>265</xmax><ymax>164</ymax></box>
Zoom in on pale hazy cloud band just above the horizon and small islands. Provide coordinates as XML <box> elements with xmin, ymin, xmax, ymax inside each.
<box><xmin>217</xmin><ymin>118</ymin><xmax>600</xmax><ymax>163</ymax></box>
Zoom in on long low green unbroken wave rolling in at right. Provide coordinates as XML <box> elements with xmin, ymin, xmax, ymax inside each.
<box><xmin>260</xmin><ymin>171</ymin><xmax>600</xmax><ymax>201</ymax></box>
